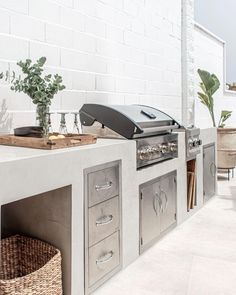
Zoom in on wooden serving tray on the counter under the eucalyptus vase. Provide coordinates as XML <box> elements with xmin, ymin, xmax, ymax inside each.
<box><xmin>0</xmin><ymin>134</ymin><xmax>97</xmax><ymax>150</ymax></box>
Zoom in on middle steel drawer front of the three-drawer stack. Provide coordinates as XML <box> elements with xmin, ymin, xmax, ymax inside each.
<box><xmin>89</xmin><ymin>197</ymin><xmax>120</xmax><ymax>246</ymax></box>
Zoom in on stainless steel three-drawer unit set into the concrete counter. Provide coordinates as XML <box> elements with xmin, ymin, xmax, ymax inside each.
<box><xmin>84</xmin><ymin>161</ymin><xmax>121</xmax><ymax>294</ymax></box>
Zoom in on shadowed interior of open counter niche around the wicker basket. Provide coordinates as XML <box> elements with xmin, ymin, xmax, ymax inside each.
<box><xmin>0</xmin><ymin>186</ymin><xmax>72</xmax><ymax>295</ymax></box>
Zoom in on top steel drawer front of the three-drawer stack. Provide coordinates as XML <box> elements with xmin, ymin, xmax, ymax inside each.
<box><xmin>88</xmin><ymin>166</ymin><xmax>119</xmax><ymax>207</ymax></box>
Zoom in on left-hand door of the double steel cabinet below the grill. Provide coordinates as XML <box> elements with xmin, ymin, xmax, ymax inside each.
<box><xmin>140</xmin><ymin>181</ymin><xmax>161</xmax><ymax>252</ymax></box>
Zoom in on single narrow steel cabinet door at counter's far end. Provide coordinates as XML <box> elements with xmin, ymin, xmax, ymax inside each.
<box><xmin>203</xmin><ymin>144</ymin><xmax>216</xmax><ymax>202</ymax></box>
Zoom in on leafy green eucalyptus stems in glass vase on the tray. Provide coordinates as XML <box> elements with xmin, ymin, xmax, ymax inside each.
<box><xmin>0</xmin><ymin>57</ymin><xmax>65</xmax><ymax>137</ymax></box>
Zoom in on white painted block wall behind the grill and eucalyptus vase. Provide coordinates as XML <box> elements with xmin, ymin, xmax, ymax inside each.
<box><xmin>0</xmin><ymin>0</ymin><xmax>182</xmax><ymax>132</ymax></box>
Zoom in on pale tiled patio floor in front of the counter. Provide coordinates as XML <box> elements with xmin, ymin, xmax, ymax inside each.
<box><xmin>95</xmin><ymin>180</ymin><xmax>236</xmax><ymax>295</ymax></box>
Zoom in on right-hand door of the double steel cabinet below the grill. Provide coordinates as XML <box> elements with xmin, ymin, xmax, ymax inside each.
<box><xmin>160</xmin><ymin>172</ymin><xmax>177</xmax><ymax>232</ymax></box>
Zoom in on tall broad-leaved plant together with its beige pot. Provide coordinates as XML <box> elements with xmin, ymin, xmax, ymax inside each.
<box><xmin>198</xmin><ymin>69</ymin><xmax>236</xmax><ymax>168</ymax></box>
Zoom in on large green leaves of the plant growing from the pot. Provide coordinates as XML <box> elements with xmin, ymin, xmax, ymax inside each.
<box><xmin>198</xmin><ymin>69</ymin><xmax>232</xmax><ymax>128</ymax></box>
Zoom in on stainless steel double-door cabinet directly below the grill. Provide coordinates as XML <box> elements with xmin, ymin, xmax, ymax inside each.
<box><xmin>140</xmin><ymin>171</ymin><xmax>177</xmax><ymax>253</ymax></box>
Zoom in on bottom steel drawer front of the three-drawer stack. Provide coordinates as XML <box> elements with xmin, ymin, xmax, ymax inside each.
<box><xmin>89</xmin><ymin>232</ymin><xmax>120</xmax><ymax>287</ymax></box>
